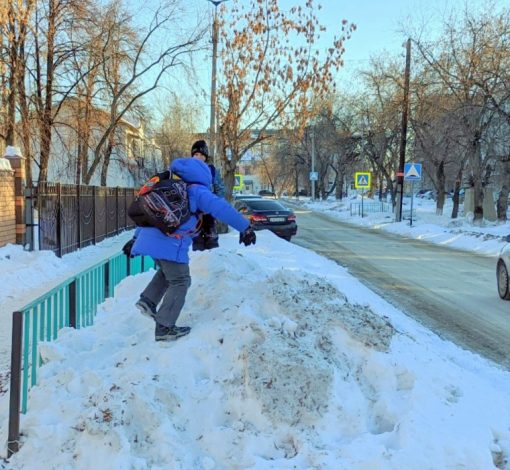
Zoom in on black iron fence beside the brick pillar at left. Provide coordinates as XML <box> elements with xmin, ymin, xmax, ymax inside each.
<box><xmin>36</xmin><ymin>182</ymin><xmax>135</xmax><ymax>257</ymax></box>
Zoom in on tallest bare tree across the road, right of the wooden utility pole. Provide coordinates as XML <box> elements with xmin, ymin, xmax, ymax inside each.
<box><xmin>414</xmin><ymin>2</ymin><xmax>510</xmax><ymax>223</ymax></box>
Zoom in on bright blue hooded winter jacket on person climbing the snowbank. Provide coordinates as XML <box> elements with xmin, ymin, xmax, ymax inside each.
<box><xmin>131</xmin><ymin>158</ymin><xmax>250</xmax><ymax>264</ymax></box>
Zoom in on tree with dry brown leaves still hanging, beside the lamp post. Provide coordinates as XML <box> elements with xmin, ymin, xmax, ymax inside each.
<box><xmin>218</xmin><ymin>0</ymin><xmax>355</xmax><ymax>199</ymax></box>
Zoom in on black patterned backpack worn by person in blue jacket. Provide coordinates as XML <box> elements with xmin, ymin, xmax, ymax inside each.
<box><xmin>128</xmin><ymin>171</ymin><xmax>191</xmax><ymax>236</ymax></box>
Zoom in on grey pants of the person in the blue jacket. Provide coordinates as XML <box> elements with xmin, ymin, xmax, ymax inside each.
<box><xmin>142</xmin><ymin>259</ymin><xmax>191</xmax><ymax>327</ymax></box>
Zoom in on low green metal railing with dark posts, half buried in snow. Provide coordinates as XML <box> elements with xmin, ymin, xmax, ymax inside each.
<box><xmin>7</xmin><ymin>253</ymin><xmax>155</xmax><ymax>456</ymax></box>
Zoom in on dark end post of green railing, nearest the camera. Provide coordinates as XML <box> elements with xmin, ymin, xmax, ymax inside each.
<box><xmin>7</xmin><ymin>312</ymin><xmax>23</xmax><ymax>457</ymax></box>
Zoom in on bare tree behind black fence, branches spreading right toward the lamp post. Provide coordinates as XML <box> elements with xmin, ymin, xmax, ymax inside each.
<box><xmin>83</xmin><ymin>0</ymin><xmax>205</xmax><ymax>184</ymax></box>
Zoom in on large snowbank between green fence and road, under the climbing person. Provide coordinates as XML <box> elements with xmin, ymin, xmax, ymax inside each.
<box><xmin>0</xmin><ymin>232</ymin><xmax>510</xmax><ymax>470</ymax></box>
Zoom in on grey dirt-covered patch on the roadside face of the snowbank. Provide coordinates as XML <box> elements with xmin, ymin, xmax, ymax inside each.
<box><xmin>244</xmin><ymin>270</ymin><xmax>395</xmax><ymax>425</ymax></box>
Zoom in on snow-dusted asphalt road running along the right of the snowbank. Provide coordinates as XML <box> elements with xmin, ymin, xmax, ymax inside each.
<box><xmin>289</xmin><ymin>204</ymin><xmax>510</xmax><ymax>370</ymax></box>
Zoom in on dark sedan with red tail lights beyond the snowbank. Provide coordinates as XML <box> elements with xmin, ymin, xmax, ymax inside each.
<box><xmin>234</xmin><ymin>199</ymin><xmax>297</xmax><ymax>241</ymax></box>
